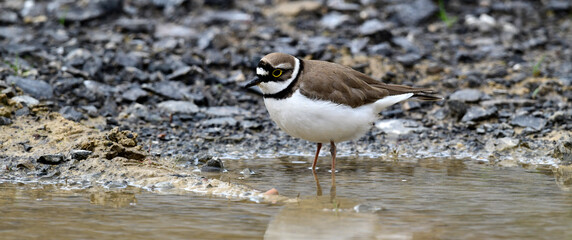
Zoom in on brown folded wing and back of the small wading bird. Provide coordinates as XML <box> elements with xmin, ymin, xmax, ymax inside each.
<box><xmin>299</xmin><ymin>60</ymin><xmax>440</xmax><ymax>108</ymax></box>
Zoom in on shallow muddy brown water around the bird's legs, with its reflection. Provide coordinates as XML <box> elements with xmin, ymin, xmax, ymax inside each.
<box><xmin>0</xmin><ymin>157</ymin><xmax>572</xmax><ymax>239</ymax></box>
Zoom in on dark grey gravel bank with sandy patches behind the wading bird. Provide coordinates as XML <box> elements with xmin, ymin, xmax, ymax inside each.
<box><xmin>0</xmin><ymin>0</ymin><xmax>572</xmax><ymax>187</ymax></box>
